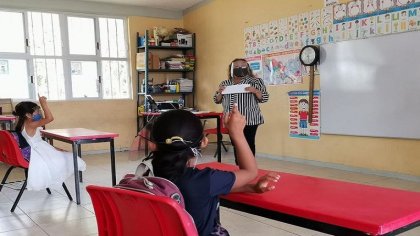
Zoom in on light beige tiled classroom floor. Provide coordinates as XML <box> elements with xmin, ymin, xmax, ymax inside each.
<box><xmin>0</xmin><ymin>148</ymin><xmax>420</xmax><ymax>236</ymax></box>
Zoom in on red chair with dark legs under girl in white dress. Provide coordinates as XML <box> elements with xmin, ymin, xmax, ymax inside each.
<box><xmin>0</xmin><ymin>130</ymin><xmax>73</xmax><ymax>212</ymax></box>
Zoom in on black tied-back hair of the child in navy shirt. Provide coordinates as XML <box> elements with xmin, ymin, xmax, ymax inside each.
<box><xmin>151</xmin><ymin>110</ymin><xmax>203</xmax><ymax>181</ymax></box>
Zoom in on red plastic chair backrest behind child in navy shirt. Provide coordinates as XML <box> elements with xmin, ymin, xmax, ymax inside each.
<box><xmin>86</xmin><ymin>185</ymin><xmax>198</xmax><ymax>236</ymax></box>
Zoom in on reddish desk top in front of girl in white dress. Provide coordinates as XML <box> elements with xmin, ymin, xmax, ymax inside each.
<box><xmin>41</xmin><ymin>128</ymin><xmax>119</xmax><ymax>141</ymax></box>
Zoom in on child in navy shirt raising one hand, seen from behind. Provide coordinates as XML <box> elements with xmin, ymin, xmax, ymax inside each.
<box><xmin>151</xmin><ymin>104</ymin><xmax>280</xmax><ymax>236</ymax></box>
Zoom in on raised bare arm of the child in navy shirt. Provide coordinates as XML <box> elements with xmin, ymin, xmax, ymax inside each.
<box><xmin>225</xmin><ymin>104</ymin><xmax>258</xmax><ymax>191</ymax></box>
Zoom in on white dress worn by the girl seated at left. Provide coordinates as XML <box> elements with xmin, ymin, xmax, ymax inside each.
<box><xmin>22</xmin><ymin>127</ymin><xmax>86</xmax><ymax>190</ymax></box>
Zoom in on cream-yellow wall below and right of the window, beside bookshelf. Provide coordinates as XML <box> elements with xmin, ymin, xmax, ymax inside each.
<box><xmin>38</xmin><ymin>16</ymin><xmax>183</xmax><ymax>151</ymax></box>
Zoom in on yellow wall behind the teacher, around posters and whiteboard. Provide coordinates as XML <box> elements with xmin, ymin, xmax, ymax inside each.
<box><xmin>184</xmin><ymin>0</ymin><xmax>420</xmax><ymax>177</ymax></box>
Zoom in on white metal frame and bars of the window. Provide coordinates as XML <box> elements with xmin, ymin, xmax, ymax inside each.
<box><xmin>0</xmin><ymin>8</ymin><xmax>133</xmax><ymax>101</ymax></box>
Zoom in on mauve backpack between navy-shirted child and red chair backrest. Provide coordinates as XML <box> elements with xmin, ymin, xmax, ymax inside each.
<box><xmin>115</xmin><ymin>174</ymin><xmax>185</xmax><ymax>209</ymax></box>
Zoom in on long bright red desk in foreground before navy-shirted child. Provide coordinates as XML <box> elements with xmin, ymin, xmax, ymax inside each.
<box><xmin>197</xmin><ymin>162</ymin><xmax>420</xmax><ymax>236</ymax></box>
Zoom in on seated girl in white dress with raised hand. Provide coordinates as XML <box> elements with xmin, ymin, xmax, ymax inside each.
<box><xmin>13</xmin><ymin>97</ymin><xmax>86</xmax><ymax>190</ymax></box>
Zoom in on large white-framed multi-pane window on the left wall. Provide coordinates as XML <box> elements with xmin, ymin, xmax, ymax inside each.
<box><xmin>0</xmin><ymin>11</ymin><xmax>131</xmax><ymax>100</ymax></box>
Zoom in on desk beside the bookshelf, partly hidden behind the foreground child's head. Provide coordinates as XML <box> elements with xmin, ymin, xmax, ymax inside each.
<box><xmin>140</xmin><ymin>111</ymin><xmax>223</xmax><ymax>162</ymax></box>
